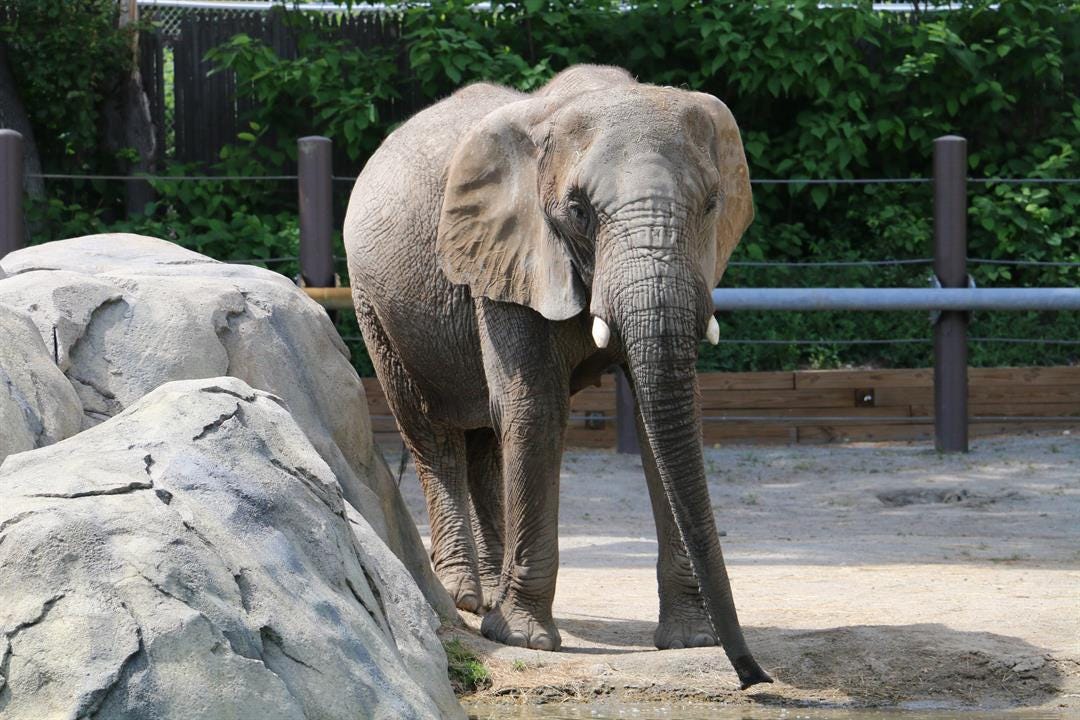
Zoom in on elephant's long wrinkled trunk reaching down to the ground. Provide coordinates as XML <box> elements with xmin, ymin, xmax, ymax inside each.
<box><xmin>610</xmin><ymin>273</ymin><xmax>772</xmax><ymax>689</ymax></box>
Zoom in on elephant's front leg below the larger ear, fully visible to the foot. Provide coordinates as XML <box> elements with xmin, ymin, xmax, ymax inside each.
<box><xmin>477</xmin><ymin>300</ymin><xmax>569</xmax><ymax>650</ymax></box>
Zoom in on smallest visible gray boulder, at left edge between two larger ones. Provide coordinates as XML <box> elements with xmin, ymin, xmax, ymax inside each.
<box><xmin>0</xmin><ymin>304</ymin><xmax>82</xmax><ymax>460</ymax></box>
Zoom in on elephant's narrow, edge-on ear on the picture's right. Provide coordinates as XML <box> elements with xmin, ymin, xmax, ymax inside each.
<box><xmin>694</xmin><ymin>93</ymin><xmax>754</xmax><ymax>287</ymax></box>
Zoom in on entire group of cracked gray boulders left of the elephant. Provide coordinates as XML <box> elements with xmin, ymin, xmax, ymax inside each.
<box><xmin>0</xmin><ymin>234</ymin><xmax>464</xmax><ymax>720</ymax></box>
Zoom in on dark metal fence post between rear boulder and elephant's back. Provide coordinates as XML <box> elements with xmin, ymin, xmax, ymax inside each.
<box><xmin>296</xmin><ymin>136</ymin><xmax>334</xmax><ymax>287</ymax></box>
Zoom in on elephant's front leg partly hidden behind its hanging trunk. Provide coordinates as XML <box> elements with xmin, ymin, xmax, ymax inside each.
<box><xmin>637</xmin><ymin>408</ymin><xmax>716</xmax><ymax>650</ymax></box>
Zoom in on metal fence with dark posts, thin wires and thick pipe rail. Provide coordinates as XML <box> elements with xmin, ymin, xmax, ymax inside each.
<box><xmin>0</xmin><ymin>130</ymin><xmax>1080</xmax><ymax>452</ymax></box>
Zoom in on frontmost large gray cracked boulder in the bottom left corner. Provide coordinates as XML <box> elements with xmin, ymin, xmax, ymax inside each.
<box><xmin>0</xmin><ymin>378</ymin><xmax>464</xmax><ymax>720</ymax></box>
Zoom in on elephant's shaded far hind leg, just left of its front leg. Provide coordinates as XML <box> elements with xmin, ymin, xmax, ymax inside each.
<box><xmin>465</xmin><ymin>427</ymin><xmax>504</xmax><ymax>609</ymax></box>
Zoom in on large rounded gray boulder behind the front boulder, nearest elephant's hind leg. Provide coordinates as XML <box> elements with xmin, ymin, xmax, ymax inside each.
<box><xmin>0</xmin><ymin>233</ymin><xmax>457</xmax><ymax>619</ymax></box>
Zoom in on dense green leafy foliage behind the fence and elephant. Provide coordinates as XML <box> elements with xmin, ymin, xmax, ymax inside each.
<box><xmin>5</xmin><ymin>0</ymin><xmax>1080</xmax><ymax>371</ymax></box>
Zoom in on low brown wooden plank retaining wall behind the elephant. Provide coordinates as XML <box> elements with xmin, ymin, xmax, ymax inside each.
<box><xmin>364</xmin><ymin>367</ymin><xmax>1080</xmax><ymax>448</ymax></box>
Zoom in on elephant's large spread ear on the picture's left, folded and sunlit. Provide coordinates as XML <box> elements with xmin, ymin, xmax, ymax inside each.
<box><xmin>435</xmin><ymin>98</ymin><xmax>586</xmax><ymax>320</ymax></box>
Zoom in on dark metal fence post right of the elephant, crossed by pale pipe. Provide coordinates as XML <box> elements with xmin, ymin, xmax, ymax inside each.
<box><xmin>934</xmin><ymin>135</ymin><xmax>968</xmax><ymax>452</ymax></box>
